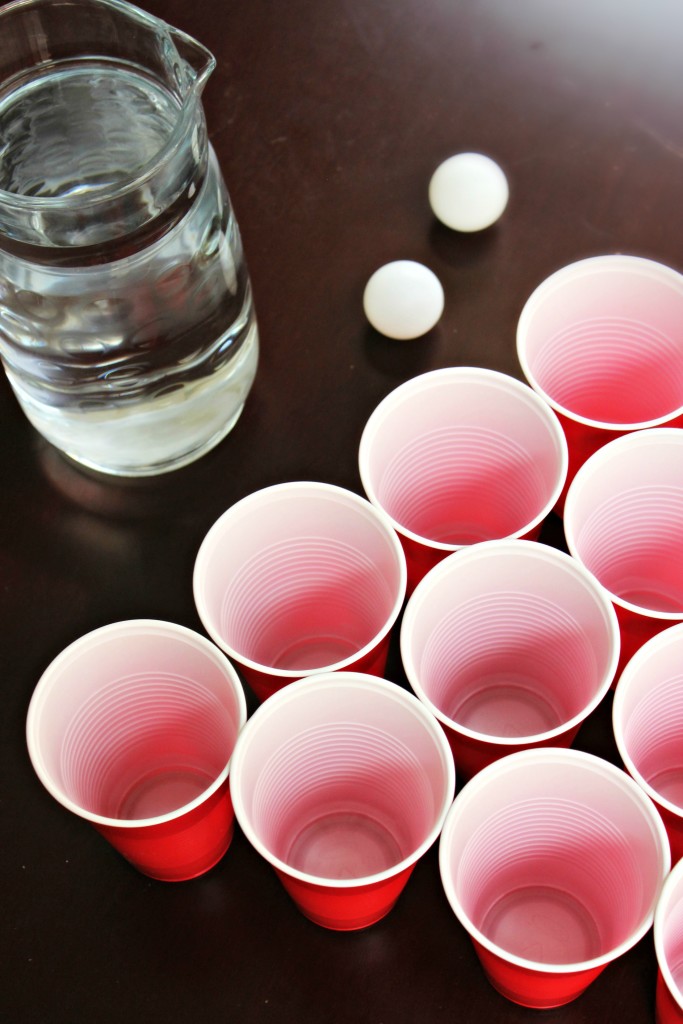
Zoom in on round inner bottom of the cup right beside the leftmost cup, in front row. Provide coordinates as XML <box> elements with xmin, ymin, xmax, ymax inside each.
<box><xmin>287</xmin><ymin>812</ymin><xmax>402</xmax><ymax>879</ymax></box>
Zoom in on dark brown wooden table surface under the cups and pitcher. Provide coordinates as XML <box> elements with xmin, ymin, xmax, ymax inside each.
<box><xmin>0</xmin><ymin>0</ymin><xmax>683</xmax><ymax>1024</ymax></box>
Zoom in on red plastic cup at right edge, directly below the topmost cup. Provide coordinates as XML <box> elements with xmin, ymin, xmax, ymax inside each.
<box><xmin>564</xmin><ymin>427</ymin><xmax>683</xmax><ymax>676</ymax></box>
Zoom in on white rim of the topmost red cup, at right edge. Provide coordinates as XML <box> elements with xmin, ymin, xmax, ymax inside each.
<box><xmin>516</xmin><ymin>253</ymin><xmax>683</xmax><ymax>432</ymax></box>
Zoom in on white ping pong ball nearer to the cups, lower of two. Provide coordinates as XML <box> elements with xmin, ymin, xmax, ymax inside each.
<box><xmin>362</xmin><ymin>259</ymin><xmax>443</xmax><ymax>340</ymax></box>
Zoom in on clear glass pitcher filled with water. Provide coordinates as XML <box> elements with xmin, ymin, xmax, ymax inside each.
<box><xmin>0</xmin><ymin>0</ymin><xmax>258</xmax><ymax>476</ymax></box>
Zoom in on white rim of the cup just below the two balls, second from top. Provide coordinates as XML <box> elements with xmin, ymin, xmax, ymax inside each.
<box><xmin>358</xmin><ymin>366</ymin><xmax>569</xmax><ymax>552</ymax></box>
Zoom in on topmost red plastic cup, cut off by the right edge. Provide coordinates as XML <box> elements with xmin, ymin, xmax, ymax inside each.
<box><xmin>517</xmin><ymin>255</ymin><xmax>683</xmax><ymax>509</ymax></box>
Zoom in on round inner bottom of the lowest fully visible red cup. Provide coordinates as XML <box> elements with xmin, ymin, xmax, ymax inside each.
<box><xmin>481</xmin><ymin>886</ymin><xmax>602</xmax><ymax>964</ymax></box>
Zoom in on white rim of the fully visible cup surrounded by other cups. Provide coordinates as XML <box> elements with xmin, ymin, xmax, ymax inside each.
<box><xmin>399</xmin><ymin>539</ymin><xmax>621</xmax><ymax>748</ymax></box>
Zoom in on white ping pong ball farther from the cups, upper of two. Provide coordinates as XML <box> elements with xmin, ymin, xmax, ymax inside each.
<box><xmin>429</xmin><ymin>153</ymin><xmax>510</xmax><ymax>231</ymax></box>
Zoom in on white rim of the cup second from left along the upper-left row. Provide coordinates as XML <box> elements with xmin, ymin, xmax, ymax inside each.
<box><xmin>193</xmin><ymin>480</ymin><xmax>408</xmax><ymax>682</ymax></box>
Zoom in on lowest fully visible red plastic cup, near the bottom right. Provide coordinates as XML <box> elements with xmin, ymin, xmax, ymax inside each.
<box><xmin>439</xmin><ymin>748</ymin><xmax>671</xmax><ymax>1009</ymax></box>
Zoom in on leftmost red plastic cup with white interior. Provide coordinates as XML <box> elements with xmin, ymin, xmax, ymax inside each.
<box><xmin>27</xmin><ymin>620</ymin><xmax>247</xmax><ymax>882</ymax></box>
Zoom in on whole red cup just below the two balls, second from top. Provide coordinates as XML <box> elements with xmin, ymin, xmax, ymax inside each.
<box><xmin>358</xmin><ymin>367</ymin><xmax>567</xmax><ymax>592</ymax></box>
